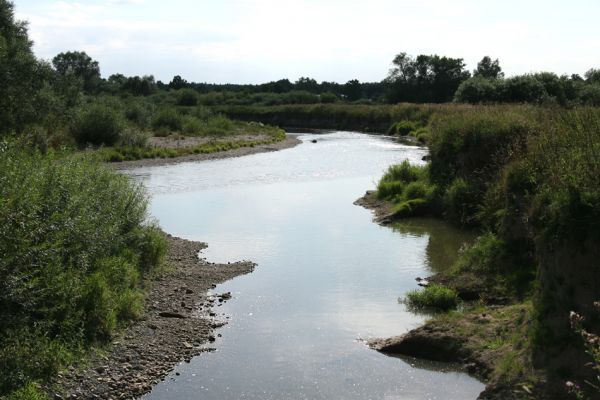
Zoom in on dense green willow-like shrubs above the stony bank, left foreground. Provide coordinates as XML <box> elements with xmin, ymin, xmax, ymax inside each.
<box><xmin>0</xmin><ymin>142</ymin><xmax>166</xmax><ymax>399</ymax></box>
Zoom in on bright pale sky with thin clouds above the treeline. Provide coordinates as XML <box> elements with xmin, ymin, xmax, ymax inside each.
<box><xmin>13</xmin><ymin>0</ymin><xmax>600</xmax><ymax>83</ymax></box>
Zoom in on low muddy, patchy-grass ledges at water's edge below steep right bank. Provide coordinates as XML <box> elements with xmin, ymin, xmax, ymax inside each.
<box><xmin>354</xmin><ymin>191</ymin><xmax>555</xmax><ymax>400</ymax></box>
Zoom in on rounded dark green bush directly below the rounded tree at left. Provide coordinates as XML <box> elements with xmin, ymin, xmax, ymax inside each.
<box><xmin>71</xmin><ymin>104</ymin><xmax>123</xmax><ymax>146</ymax></box>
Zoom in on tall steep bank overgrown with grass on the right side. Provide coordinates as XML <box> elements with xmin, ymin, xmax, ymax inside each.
<box><xmin>376</xmin><ymin>106</ymin><xmax>600</xmax><ymax>398</ymax></box>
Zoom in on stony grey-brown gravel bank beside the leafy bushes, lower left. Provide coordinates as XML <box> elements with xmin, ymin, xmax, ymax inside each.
<box><xmin>52</xmin><ymin>235</ymin><xmax>254</xmax><ymax>399</ymax></box>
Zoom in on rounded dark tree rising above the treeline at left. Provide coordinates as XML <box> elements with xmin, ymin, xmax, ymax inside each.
<box><xmin>52</xmin><ymin>51</ymin><xmax>100</xmax><ymax>93</ymax></box>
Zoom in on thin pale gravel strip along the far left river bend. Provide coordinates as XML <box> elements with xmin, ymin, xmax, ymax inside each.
<box><xmin>107</xmin><ymin>135</ymin><xmax>302</xmax><ymax>170</ymax></box>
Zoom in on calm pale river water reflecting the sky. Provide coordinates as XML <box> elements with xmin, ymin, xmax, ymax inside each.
<box><xmin>129</xmin><ymin>132</ymin><xmax>484</xmax><ymax>400</ymax></box>
